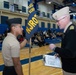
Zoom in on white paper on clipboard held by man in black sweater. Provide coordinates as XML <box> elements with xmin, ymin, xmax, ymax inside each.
<box><xmin>43</xmin><ymin>55</ymin><xmax>61</xmax><ymax>68</ymax></box>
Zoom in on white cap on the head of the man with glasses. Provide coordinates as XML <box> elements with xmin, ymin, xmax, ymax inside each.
<box><xmin>52</xmin><ymin>7</ymin><xmax>70</xmax><ymax>20</ymax></box>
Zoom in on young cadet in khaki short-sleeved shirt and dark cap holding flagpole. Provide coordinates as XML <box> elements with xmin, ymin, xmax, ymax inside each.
<box><xmin>2</xmin><ymin>18</ymin><xmax>27</xmax><ymax>75</ymax></box>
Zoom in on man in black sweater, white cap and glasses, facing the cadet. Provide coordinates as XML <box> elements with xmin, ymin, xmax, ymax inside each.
<box><xmin>49</xmin><ymin>7</ymin><xmax>76</xmax><ymax>75</ymax></box>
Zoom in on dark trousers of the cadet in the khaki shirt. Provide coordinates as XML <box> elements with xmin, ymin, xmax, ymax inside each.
<box><xmin>2</xmin><ymin>66</ymin><xmax>17</xmax><ymax>75</ymax></box>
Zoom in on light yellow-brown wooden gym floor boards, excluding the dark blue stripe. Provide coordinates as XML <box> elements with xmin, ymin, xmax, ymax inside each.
<box><xmin>0</xmin><ymin>43</ymin><xmax>63</xmax><ymax>75</ymax></box>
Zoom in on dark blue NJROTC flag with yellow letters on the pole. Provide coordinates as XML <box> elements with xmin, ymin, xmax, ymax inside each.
<box><xmin>26</xmin><ymin>0</ymin><xmax>38</xmax><ymax>39</ymax></box>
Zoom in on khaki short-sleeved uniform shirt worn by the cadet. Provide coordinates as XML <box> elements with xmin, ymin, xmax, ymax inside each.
<box><xmin>2</xmin><ymin>33</ymin><xmax>20</xmax><ymax>66</ymax></box>
